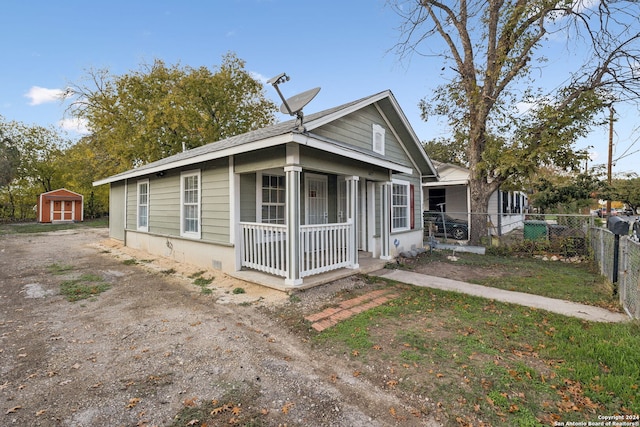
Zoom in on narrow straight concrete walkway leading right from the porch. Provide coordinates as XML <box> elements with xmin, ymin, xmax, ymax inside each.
<box><xmin>372</xmin><ymin>270</ymin><xmax>629</xmax><ymax>322</ymax></box>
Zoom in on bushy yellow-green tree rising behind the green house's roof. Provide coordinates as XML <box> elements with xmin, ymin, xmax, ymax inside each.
<box><xmin>67</xmin><ymin>53</ymin><xmax>276</xmax><ymax>173</ymax></box>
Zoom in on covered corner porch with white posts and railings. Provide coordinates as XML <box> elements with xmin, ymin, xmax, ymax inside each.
<box><xmin>233</xmin><ymin>166</ymin><xmax>391</xmax><ymax>289</ymax></box>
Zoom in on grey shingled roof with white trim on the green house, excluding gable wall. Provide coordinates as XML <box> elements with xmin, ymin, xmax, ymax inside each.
<box><xmin>93</xmin><ymin>90</ymin><xmax>437</xmax><ymax>186</ymax></box>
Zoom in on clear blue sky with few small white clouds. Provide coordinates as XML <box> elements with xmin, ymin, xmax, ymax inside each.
<box><xmin>0</xmin><ymin>0</ymin><xmax>640</xmax><ymax>172</ymax></box>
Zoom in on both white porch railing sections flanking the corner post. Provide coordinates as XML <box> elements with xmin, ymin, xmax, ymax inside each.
<box><xmin>240</xmin><ymin>222</ymin><xmax>355</xmax><ymax>278</ymax></box>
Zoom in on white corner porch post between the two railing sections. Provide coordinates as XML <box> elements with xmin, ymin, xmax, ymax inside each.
<box><xmin>284</xmin><ymin>166</ymin><xmax>302</xmax><ymax>286</ymax></box>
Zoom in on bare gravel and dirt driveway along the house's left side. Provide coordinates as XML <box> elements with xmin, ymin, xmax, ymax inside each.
<box><xmin>0</xmin><ymin>229</ymin><xmax>437</xmax><ymax>427</ymax></box>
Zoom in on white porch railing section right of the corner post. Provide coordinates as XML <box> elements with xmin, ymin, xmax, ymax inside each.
<box><xmin>300</xmin><ymin>222</ymin><xmax>353</xmax><ymax>277</ymax></box>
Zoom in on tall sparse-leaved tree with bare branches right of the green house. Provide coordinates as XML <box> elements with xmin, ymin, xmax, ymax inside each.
<box><xmin>390</xmin><ymin>0</ymin><xmax>640</xmax><ymax>243</ymax></box>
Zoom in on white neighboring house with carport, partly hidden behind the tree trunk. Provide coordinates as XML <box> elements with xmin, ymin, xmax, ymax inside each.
<box><xmin>422</xmin><ymin>161</ymin><xmax>529</xmax><ymax>236</ymax></box>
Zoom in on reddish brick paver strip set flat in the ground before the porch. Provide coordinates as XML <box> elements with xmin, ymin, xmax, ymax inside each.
<box><xmin>305</xmin><ymin>289</ymin><xmax>398</xmax><ymax>332</ymax></box>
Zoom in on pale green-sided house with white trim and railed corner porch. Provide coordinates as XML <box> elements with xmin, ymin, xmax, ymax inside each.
<box><xmin>94</xmin><ymin>91</ymin><xmax>437</xmax><ymax>289</ymax></box>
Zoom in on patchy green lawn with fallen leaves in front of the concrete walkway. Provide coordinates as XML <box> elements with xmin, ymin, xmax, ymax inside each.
<box><xmin>313</xmin><ymin>284</ymin><xmax>640</xmax><ymax>426</ymax></box>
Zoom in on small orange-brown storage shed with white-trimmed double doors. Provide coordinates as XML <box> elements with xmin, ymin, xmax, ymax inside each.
<box><xmin>37</xmin><ymin>188</ymin><xmax>84</xmax><ymax>222</ymax></box>
